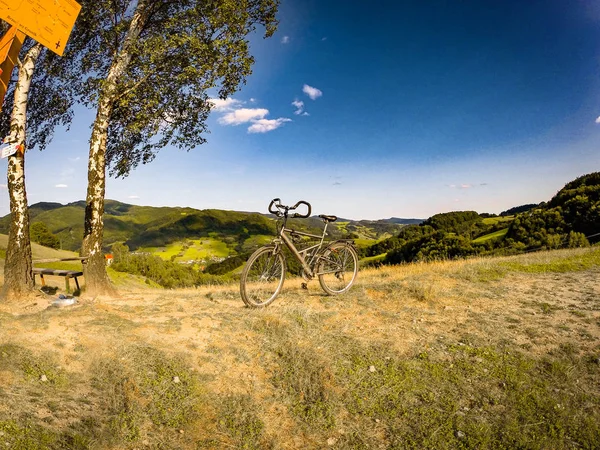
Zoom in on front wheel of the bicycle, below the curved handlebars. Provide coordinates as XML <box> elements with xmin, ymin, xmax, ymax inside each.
<box><xmin>240</xmin><ymin>246</ymin><xmax>286</xmax><ymax>308</ymax></box>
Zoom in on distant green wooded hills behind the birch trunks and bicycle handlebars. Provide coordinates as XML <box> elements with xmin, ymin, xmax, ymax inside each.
<box><xmin>0</xmin><ymin>200</ymin><xmax>404</xmax><ymax>251</ymax></box>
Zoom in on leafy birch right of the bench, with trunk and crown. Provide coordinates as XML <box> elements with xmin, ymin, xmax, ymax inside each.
<box><xmin>65</xmin><ymin>0</ymin><xmax>279</xmax><ymax>296</ymax></box>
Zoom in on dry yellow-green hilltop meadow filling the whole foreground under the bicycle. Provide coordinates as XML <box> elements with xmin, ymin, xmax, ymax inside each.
<box><xmin>0</xmin><ymin>247</ymin><xmax>600</xmax><ymax>450</ymax></box>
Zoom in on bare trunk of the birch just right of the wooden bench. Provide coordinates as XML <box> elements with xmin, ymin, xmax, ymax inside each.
<box><xmin>81</xmin><ymin>1</ymin><xmax>150</xmax><ymax>296</ymax></box>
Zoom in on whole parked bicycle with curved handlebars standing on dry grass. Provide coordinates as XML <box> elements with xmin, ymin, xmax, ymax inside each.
<box><xmin>240</xmin><ymin>198</ymin><xmax>358</xmax><ymax>308</ymax></box>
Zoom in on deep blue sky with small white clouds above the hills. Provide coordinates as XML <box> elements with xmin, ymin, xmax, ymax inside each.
<box><xmin>0</xmin><ymin>0</ymin><xmax>600</xmax><ymax>219</ymax></box>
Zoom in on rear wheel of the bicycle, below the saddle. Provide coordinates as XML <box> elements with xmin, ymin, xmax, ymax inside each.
<box><xmin>318</xmin><ymin>242</ymin><xmax>358</xmax><ymax>295</ymax></box>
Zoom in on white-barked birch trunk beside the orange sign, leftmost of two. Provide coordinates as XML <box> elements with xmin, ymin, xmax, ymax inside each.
<box><xmin>1</xmin><ymin>44</ymin><xmax>42</xmax><ymax>301</ymax></box>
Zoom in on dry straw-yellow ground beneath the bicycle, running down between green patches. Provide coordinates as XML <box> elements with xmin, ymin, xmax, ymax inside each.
<box><xmin>0</xmin><ymin>250</ymin><xmax>600</xmax><ymax>448</ymax></box>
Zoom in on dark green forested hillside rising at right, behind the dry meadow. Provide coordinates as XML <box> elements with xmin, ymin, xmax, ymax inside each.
<box><xmin>366</xmin><ymin>172</ymin><xmax>600</xmax><ymax>264</ymax></box>
